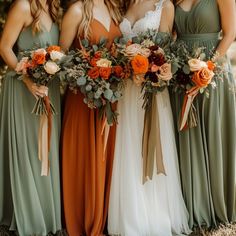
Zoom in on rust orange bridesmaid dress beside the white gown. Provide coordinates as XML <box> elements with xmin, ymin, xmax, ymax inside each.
<box><xmin>62</xmin><ymin>19</ymin><xmax>121</xmax><ymax>236</ymax></box>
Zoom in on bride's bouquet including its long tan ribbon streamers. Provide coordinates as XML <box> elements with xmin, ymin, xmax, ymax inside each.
<box><xmin>115</xmin><ymin>30</ymin><xmax>177</xmax><ymax>182</ymax></box>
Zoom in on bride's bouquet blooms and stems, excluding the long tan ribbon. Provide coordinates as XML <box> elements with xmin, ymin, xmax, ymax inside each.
<box><xmin>116</xmin><ymin>30</ymin><xmax>176</xmax><ymax>108</ymax></box>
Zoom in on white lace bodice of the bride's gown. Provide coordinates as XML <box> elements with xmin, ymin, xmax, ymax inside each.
<box><xmin>120</xmin><ymin>0</ymin><xmax>165</xmax><ymax>38</ymax></box>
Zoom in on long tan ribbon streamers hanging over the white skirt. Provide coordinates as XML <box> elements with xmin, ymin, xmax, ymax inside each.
<box><xmin>142</xmin><ymin>95</ymin><xmax>166</xmax><ymax>183</ymax></box>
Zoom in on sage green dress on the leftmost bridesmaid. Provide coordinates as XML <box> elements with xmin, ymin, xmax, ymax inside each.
<box><xmin>0</xmin><ymin>23</ymin><xmax>61</xmax><ymax>236</ymax></box>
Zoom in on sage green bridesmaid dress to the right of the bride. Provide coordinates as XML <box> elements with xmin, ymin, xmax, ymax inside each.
<box><xmin>171</xmin><ymin>0</ymin><xmax>236</xmax><ymax>227</ymax></box>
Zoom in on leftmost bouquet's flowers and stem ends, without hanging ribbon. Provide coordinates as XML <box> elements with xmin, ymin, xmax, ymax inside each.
<box><xmin>15</xmin><ymin>46</ymin><xmax>65</xmax><ymax>115</ymax></box>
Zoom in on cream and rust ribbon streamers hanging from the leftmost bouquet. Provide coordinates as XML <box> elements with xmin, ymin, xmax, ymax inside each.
<box><xmin>38</xmin><ymin>96</ymin><xmax>52</xmax><ymax>176</ymax></box>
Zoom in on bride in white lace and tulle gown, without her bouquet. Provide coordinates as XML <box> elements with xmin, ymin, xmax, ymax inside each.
<box><xmin>108</xmin><ymin>0</ymin><xmax>190</xmax><ymax>236</ymax></box>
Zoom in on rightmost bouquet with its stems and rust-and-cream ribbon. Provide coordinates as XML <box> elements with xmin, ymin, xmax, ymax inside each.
<box><xmin>172</xmin><ymin>42</ymin><xmax>224</xmax><ymax>130</ymax></box>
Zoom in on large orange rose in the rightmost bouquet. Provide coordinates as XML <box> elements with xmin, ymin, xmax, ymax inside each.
<box><xmin>192</xmin><ymin>68</ymin><xmax>214</xmax><ymax>88</ymax></box>
